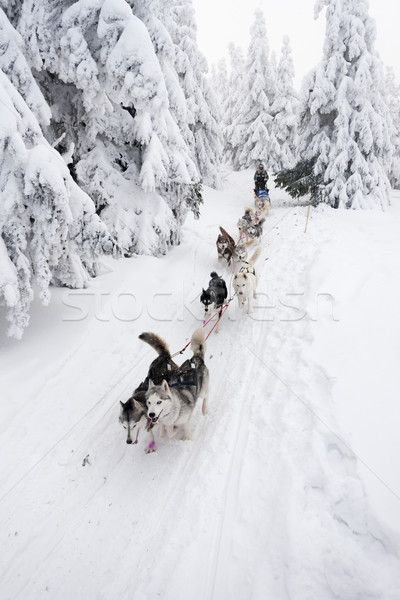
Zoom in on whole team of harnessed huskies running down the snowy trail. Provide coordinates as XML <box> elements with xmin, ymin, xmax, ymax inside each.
<box><xmin>119</xmin><ymin>185</ymin><xmax>270</xmax><ymax>453</ymax></box>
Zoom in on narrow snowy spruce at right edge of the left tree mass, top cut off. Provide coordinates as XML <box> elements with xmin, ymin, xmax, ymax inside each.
<box><xmin>163</xmin><ymin>0</ymin><xmax>222</xmax><ymax>188</ymax></box>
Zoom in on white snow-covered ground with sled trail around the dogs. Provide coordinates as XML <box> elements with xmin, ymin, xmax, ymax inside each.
<box><xmin>0</xmin><ymin>172</ymin><xmax>400</xmax><ymax>600</ymax></box>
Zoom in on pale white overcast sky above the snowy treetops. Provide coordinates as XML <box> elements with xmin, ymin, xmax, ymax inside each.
<box><xmin>193</xmin><ymin>0</ymin><xmax>400</xmax><ymax>86</ymax></box>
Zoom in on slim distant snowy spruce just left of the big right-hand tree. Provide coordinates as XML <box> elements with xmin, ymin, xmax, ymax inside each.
<box><xmin>271</xmin><ymin>36</ymin><xmax>299</xmax><ymax>170</ymax></box>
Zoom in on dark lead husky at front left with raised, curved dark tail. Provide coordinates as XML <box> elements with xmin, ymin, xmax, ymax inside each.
<box><xmin>119</xmin><ymin>332</ymin><xmax>179</xmax><ymax>451</ymax></box>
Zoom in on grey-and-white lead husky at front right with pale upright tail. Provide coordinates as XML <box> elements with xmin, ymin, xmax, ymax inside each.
<box><xmin>146</xmin><ymin>328</ymin><xmax>209</xmax><ymax>440</ymax></box>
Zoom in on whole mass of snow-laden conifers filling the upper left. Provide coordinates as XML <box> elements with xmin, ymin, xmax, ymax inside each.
<box><xmin>0</xmin><ymin>0</ymin><xmax>219</xmax><ymax>335</ymax></box>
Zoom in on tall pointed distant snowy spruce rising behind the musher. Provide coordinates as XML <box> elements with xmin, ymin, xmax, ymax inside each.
<box><xmin>233</xmin><ymin>9</ymin><xmax>279</xmax><ymax>171</ymax></box>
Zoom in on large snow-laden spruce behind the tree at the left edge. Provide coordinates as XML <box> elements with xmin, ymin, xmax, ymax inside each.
<box><xmin>19</xmin><ymin>0</ymin><xmax>203</xmax><ymax>254</ymax></box>
